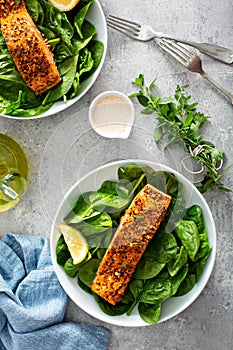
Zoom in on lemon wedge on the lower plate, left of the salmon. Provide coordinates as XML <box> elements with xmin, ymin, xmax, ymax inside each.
<box><xmin>58</xmin><ymin>224</ymin><xmax>88</xmax><ymax>265</ymax></box>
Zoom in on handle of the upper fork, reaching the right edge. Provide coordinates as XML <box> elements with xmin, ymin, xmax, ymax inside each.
<box><xmin>158</xmin><ymin>33</ymin><xmax>233</xmax><ymax>64</ymax></box>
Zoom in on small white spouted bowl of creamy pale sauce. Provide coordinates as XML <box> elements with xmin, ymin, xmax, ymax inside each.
<box><xmin>89</xmin><ymin>91</ymin><xmax>134</xmax><ymax>138</ymax></box>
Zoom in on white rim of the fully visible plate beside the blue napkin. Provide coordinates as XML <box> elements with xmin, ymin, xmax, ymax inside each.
<box><xmin>50</xmin><ymin>159</ymin><xmax>216</xmax><ymax>327</ymax></box>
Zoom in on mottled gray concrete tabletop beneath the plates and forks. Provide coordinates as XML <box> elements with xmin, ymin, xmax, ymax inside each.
<box><xmin>0</xmin><ymin>0</ymin><xmax>233</xmax><ymax>350</ymax></box>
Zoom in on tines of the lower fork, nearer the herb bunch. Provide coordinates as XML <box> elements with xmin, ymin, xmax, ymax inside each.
<box><xmin>159</xmin><ymin>39</ymin><xmax>195</xmax><ymax>66</ymax></box>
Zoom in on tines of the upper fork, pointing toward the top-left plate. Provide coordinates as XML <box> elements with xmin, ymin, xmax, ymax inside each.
<box><xmin>107</xmin><ymin>15</ymin><xmax>140</xmax><ymax>38</ymax></box>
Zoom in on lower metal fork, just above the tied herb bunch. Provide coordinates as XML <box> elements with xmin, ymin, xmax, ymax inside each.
<box><xmin>159</xmin><ymin>39</ymin><xmax>233</xmax><ymax>104</ymax></box>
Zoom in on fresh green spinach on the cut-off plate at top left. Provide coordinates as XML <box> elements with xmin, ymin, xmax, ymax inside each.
<box><xmin>0</xmin><ymin>0</ymin><xmax>104</xmax><ymax>117</ymax></box>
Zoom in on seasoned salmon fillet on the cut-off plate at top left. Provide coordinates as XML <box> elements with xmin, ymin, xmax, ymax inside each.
<box><xmin>0</xmin><ymin>0</ymin><xmax>61</xmax><ymax>95</ymax></box>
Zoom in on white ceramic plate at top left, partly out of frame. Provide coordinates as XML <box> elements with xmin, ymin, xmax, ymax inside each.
<box><xmin>1</xmin><ymin>0</ymin><xmax>107</xmax><ymax>120</ymax></box>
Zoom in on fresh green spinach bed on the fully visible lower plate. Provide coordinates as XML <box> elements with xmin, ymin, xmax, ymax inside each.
<box><xmin>56</xmin><ymin>164</ymin><xmax>211</xmax><ymax>324</ymax></box>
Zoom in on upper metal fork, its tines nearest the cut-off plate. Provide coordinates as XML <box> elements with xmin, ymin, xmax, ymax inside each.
<box><xmin>107</xmin><ymin>15</ymin><xmax>233</xmax><ymax>64</ymax></box>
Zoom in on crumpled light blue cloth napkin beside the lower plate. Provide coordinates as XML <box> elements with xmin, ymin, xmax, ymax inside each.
<box><xmin>0</xmin><ymin>234</ymin><xmax>110</xmax><ymax>350</ymax></box>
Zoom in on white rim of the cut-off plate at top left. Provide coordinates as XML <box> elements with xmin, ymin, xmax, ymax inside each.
<box><xmin>0</xmin><ymin>0</ymin><xmax>108</xmax><ymax>120</ymax></box>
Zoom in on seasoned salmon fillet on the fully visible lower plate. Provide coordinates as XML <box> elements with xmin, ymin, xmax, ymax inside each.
<box><xmin>91</xmin><ymin>184</ymin><xmax>171</xmax><ymax>305</ymax></box>
